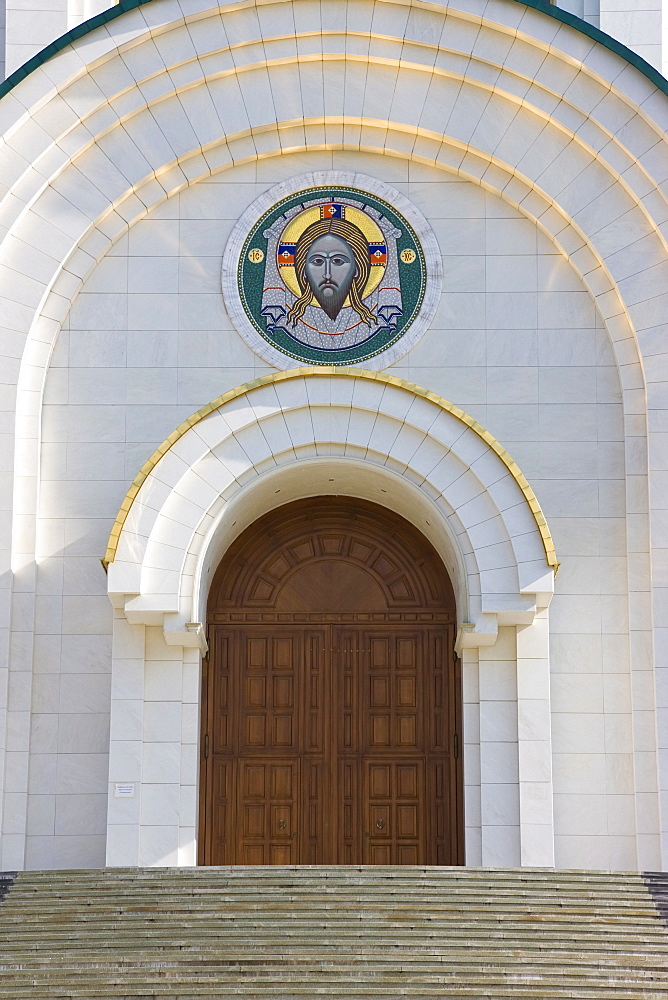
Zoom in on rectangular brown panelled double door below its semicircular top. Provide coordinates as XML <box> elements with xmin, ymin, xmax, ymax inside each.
<box><xmin>200</xmin><ymin>622</ymin><xmax>461</xmax><ymax>865</ymax></box>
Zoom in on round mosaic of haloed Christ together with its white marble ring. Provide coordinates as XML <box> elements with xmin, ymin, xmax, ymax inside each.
<box><xmin>223</xmin><ymin>172</ymin><xmax>441</xmax><ymax>368</ymax></box>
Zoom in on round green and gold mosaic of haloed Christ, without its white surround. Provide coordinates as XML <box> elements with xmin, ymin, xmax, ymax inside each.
<box><xmin>230</xmin><ymin>184</ymin><xmax>427</xmax><ymax>365</ymax></box>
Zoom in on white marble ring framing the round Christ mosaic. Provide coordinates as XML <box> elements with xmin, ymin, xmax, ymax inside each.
<box><xmin>221</xmin><ymin>170</ymin><xmax>443</xmax><ymax>371</ymax></box>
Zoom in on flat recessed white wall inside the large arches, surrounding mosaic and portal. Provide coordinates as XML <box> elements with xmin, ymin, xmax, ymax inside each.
<box><xmin>27</xmin><ymin>153</ymin><xmax>637</xmax><ymax>868</ymax></box>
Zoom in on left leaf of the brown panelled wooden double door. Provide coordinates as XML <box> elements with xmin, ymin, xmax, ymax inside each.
<box><xmin>209</xmin><ymin>626</ymin><xmax>335</xmax><ymax>864</ymax></box>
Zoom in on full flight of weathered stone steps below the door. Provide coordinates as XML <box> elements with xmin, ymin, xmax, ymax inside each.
<box><xmin>0</xmin><ymin>867</ymin><xmax>668</xmax><ymax>1000</ymax></box>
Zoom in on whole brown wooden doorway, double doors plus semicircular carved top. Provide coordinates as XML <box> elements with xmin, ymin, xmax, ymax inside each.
<box><xmin>199</xmin><ymin>496</ymin><xmax>463</xmax><ymax>865</ymax></box>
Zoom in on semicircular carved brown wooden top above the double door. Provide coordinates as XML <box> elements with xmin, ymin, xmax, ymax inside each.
<box><xmin>208</xmin><ymin>496</ymin><xmax>455</xmax><ymax>622</ymax></box>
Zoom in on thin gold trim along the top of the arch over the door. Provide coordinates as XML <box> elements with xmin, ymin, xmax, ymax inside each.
<box><xmin>102</xmin><ymin>366</ymin><xmax>559</xmax><ymax>573</ymax></box>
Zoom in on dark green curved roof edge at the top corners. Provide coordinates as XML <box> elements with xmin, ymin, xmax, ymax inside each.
<box><xmin>0</xmin><ymin>0</ymin><xmax>668</xmax><ymax>98</ymax></box>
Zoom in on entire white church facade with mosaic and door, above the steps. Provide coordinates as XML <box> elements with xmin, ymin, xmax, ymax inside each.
<box><xmin>0</xmin><ymin>0</ymin><xmax>668</xmax><ymax>870</ymax></box>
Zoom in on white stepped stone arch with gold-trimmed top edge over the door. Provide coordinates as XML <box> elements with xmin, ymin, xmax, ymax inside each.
<box><xmin>106</xmin><ymin>369</ymin><xmax>557</xmax><ymax>645</ymax></box>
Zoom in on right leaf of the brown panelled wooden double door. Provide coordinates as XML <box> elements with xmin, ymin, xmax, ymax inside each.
<box><xmin>333</xmin><ymin>625</ymin><xmax>455</xmax><ymax>864</ymax></box>
